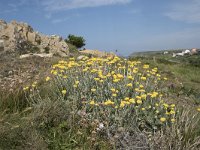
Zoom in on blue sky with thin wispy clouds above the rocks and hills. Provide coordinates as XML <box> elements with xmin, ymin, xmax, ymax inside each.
<box><xmin>0</xmin><ymin>0</ymin><xmax>200</xmax><ymax>55</ymax></box>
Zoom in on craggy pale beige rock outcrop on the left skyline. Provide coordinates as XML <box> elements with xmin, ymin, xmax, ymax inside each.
<box><xmin>0</xmin><ymin>20</ymin><xmax>69</xmax><ymax>57</ymax></box>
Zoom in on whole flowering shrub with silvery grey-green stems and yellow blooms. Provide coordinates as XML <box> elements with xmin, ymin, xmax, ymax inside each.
<box><xmin>24</xmin><ymin>57</ymin><xmax>176</xmax><ymax>131</ymax></box>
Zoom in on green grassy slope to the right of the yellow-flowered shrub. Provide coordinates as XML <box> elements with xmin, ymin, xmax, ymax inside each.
<box><xmin>130</xmin><ymin>52</ymin><xmax>200</xmax><ymax>104</ymax></box>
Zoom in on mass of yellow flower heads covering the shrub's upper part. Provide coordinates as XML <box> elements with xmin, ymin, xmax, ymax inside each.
<box><xmin>27</xmin><ymin>57</ymin><xmax>177</xmax><ymax>123</ymax></box>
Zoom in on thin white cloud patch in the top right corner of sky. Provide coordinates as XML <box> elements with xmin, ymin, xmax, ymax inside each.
<box><xmin>165</xmin><ymin>0</ymin><xmax>200</xmax><ymax>23</ymax></box>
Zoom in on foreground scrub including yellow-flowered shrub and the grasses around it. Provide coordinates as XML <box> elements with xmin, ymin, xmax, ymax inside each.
<box><xmin>0</xmin><ymin>56</ymin><xmax>200</xmax><ymax>150</ymax></box>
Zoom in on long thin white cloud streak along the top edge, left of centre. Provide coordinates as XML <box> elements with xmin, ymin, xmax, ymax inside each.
<box><xmin>42</xmin><ymin>0</ymin><xmax>132</xmax><ymax>11</ymax></box>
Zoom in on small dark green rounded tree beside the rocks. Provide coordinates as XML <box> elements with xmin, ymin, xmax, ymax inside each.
<box><xmin>65</xmin><ymin>34</ymin><xmax>85</xmax><ymax>48</ymax></box>
